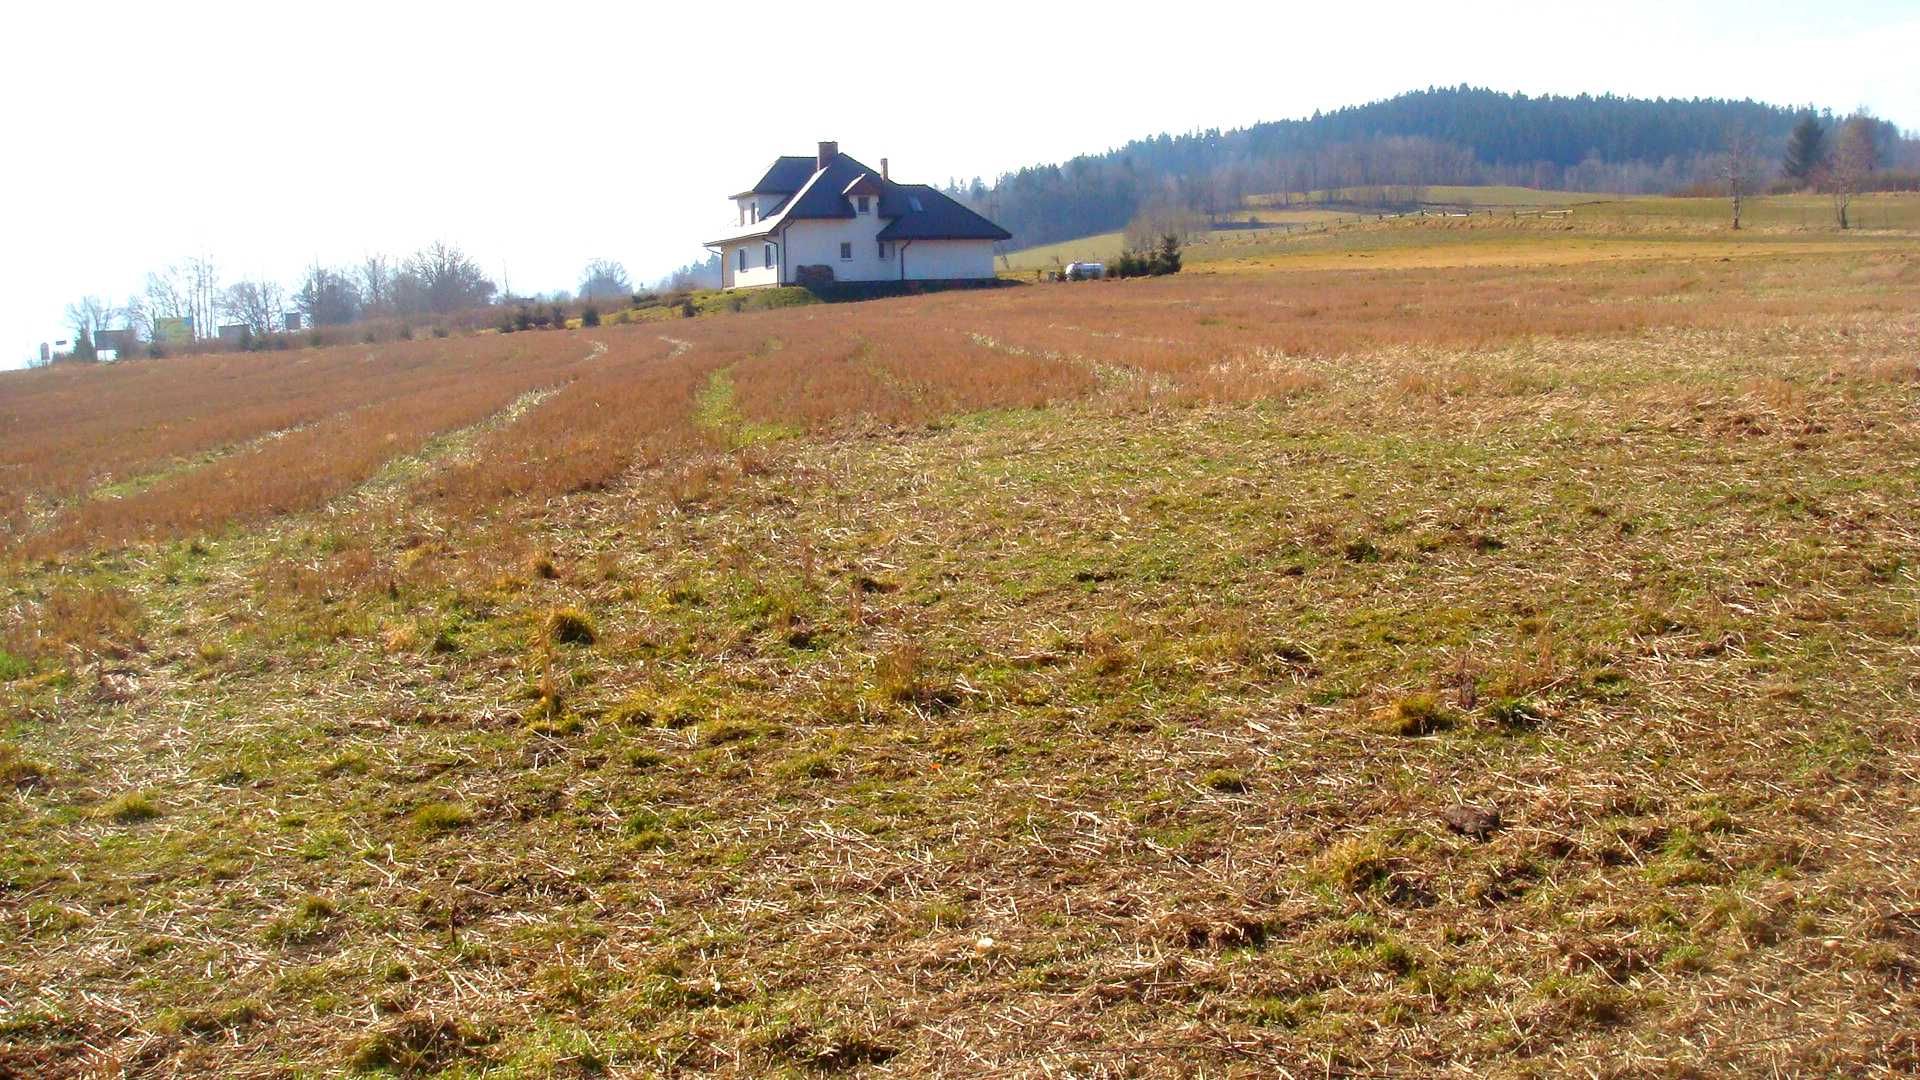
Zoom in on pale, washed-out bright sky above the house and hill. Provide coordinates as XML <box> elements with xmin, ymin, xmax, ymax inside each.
<box><xmin>0</xmin><ymin>0</ymin><xmax>1920</xmax><ymax>367</ymax></box>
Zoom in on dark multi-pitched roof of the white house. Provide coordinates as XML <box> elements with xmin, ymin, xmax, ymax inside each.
<box><xmin>714</xmin><ymin>154</ymin><xmax>1014</xmax><ymax>244</ymax></box>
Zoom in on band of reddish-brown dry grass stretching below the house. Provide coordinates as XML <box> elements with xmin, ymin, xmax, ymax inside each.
<box><xmin>0</xmin><ymin>243</ymin><xmax>1920</xmax><ymax>557</ymax></box>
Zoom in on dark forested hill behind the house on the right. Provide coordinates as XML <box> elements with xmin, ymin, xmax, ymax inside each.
<box><xmin>954</xmin><ymin>86</ymin><xmax>1899</xmax><ymax>248</ymax></box>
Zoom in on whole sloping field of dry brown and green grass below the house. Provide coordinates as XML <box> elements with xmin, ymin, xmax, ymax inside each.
<box><xmin>0</xmin><ymin>199</ymin><xmax>1920</xmax><ymax>1076</ymax></box>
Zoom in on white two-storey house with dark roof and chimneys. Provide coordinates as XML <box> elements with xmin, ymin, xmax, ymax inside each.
<box><xmin>707</xmin><ymin>142</ymin><xmax>1012</xmax><ymax>288</ymax></box>
